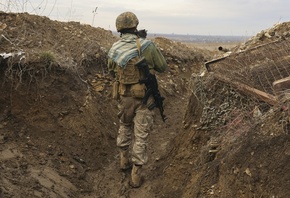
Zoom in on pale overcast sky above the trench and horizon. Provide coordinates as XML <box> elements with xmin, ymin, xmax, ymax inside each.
<box><xmin>0</xmin><ymin>0</ymin><xmax>290</xmax><ymax>36</ymax></box>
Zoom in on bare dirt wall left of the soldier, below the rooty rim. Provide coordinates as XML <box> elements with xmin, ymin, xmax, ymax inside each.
<box><xmin>0</xmin><ymin>62</ymin><xmax>117</xmax><ymax>197</ymax></box>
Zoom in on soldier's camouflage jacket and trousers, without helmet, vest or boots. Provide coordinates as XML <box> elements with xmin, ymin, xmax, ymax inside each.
<box><xmin>108</xmin><ymin>34</ymin><xmax>167</xmax><ymax>165</ymax></box>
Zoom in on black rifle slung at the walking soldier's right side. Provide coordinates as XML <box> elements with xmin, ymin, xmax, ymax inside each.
<box><xmin>135</xmin><ymin>57</ymin><xmax>167</xmax><ymax>122</ymax></box>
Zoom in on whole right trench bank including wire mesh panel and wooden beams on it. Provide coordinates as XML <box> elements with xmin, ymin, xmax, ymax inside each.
<box><xmin>164</xmin><ymin>20</ymin><xmax>290</xmax><ymax>197</ymax></box>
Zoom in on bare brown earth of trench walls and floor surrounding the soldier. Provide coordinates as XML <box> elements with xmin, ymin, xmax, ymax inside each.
<box><xmin>0</xmin><ymin>13</ymin><xmax>290</xmax><ymax>198</ymax></box>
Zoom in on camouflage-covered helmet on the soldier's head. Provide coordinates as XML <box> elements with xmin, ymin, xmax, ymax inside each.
<box><xmin>116</xmin><ymin>12</ymin><xmax>139</xmax><ymax>32</ymax></box>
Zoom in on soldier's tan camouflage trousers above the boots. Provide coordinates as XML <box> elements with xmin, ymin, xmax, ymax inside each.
<box><xmin>117</xmin><ymin>96</ymin><xmax>154</xmax><ymax>165</ymax></box>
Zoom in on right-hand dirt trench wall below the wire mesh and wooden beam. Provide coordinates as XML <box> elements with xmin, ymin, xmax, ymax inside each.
<box><xmin>155</xmin><ymin>70</ymin><xmax>290</xmax><ymax>198</ymax></box>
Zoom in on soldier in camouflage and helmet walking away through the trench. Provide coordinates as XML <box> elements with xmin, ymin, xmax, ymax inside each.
<box><xmin>108</xmin><ymin>12</ymin><xmax>167</xmax><ymax>187</ymax></box>
